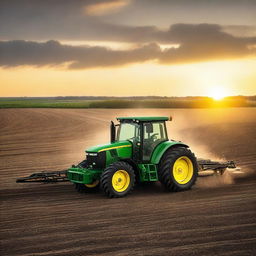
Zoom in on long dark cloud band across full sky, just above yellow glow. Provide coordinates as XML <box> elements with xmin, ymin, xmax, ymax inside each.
<box><xmin>0</xmin><ymin>24</ymin><xmax>256</xmax><ymax>69</ymax></box>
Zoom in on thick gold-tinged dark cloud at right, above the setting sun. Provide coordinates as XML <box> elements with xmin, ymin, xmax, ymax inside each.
<box><xmin>160</xmin><ymin>24</ymin><xmax>256</xmax><ymax>64</ymax></box>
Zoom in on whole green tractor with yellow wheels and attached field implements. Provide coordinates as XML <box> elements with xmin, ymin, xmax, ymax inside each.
<box><xmin>17</xmin><ymin>116</ymin><xmax>235</xmax><ymax>198</ymax></box>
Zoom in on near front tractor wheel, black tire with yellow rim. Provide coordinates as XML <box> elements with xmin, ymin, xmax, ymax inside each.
<box><xmin>100</xmin><ymin>162</ymin><xmax>135</xmax><ymax>198</ymax></box>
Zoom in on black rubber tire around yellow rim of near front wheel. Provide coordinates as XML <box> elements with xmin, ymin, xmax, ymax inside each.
<box><xmin>100</xmin><ymin>161</ymin><xmax>135</xmax><ymax>198</ymax></box>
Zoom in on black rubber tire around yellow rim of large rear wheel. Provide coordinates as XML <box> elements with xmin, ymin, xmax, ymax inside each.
<box><xmin>158</xmin><ymin>147</ymin><xmax>198</xmax><ymax>192</ymax></box>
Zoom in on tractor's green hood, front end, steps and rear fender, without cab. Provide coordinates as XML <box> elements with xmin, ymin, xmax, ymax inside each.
<box><xmin>68</xmin><ymin>141</ymin><xmax>186</xmax><ymax>184</ymax></box>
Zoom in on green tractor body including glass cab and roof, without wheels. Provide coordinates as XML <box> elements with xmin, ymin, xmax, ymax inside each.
<box><xmin>67</xmin><ymin>117</ymin><xmax>196</xmax><ymax>197</ymax></box>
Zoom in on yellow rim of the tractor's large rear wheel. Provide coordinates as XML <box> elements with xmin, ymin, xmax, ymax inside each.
<box><xmin>172</xmin><ymin>156</ymin><xmax>194</xmax><ymax>184</ymax></box>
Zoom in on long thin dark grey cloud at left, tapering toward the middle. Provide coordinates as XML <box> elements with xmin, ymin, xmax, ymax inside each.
<box><xmin>0</xmin><ymin>40</ymin><xmax>161</xmax><ymax>69</ymax></box>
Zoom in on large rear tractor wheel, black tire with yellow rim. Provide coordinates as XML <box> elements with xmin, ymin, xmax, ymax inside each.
<box><xmin>158</xmin><ymin>147</ymin><xmax>198</xmax><ymax>192</ymax></box>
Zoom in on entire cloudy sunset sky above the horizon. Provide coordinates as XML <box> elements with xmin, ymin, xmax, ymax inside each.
<box><xmin>0</xmin><ymin>0</ymin><xmax>256</xmax><ymax>98</ymax></box>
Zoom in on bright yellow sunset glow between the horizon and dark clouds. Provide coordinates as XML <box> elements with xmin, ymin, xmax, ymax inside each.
<box><xmin>0</xmin><ymin>60</ymin><xmax>256</xmax><ymax>99</ymax></box>
